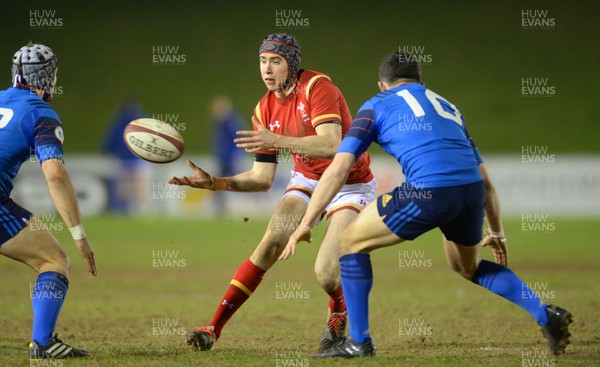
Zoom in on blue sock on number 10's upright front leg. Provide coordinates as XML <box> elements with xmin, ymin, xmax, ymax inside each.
<box><xmin>340</xmin><ymin>254</ymin><xmax>373</xmax><ymax>344</ymax></box>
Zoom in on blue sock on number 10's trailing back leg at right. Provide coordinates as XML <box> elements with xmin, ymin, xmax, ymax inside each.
<box><xmin>473</xmin><ymin>260</ymin><xmax>548</xmax><ymax>326</ymax></box>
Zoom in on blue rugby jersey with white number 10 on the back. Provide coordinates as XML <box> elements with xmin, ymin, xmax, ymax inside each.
<box><xmin>338</xmin><ymin>83</ymin><xmax>482</xmax><ymax>188</ymax></box>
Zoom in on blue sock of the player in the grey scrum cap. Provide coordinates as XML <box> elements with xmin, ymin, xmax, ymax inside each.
<box><xmin>31</xmin><ymin>271</ymin><xmax>69</xmax><ymax>346</ymax></box>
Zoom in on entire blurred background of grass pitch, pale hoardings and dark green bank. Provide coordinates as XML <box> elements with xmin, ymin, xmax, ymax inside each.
<box><xmin>0</xmin><ymin>4</ymin><xmax>600</xmax><ymax>367</ymax></box>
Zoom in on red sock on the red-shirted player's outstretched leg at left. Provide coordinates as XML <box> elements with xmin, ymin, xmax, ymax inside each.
<box><xmin>210</xmin><ymin>259</ymin><xmax>265</xmax><ymax>338</ymax></box>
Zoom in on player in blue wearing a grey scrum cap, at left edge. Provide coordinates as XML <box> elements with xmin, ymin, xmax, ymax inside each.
<box><xmin>0</xmin><ymin>44</ymin><xmax>96</xmax><ymax>360</ymax></box>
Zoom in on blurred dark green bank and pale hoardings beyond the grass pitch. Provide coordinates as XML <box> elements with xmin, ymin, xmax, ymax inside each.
<box><xmin>0</xmin><ymin>1</ymin><xmax>600</xmax><ymax>215</ymax></box>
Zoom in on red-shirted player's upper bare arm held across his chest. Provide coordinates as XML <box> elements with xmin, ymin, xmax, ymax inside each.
<box><xmin>234</xmin><ymin>116</ymin><xmax>342</xmax><ymax>158</ymax></box>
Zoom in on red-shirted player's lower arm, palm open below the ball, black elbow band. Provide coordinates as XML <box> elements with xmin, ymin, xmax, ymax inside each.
<box><xmin>169</xmin><ymin>159</ymin><xmax>277</xmax><ymax>192</ymax></box>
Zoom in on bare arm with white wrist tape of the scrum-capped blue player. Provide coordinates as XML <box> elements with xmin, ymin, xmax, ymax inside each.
<box><xmin>42</xmin><ymin>158</ymin><xmax>97</xmax><ymax>275</ymax></box>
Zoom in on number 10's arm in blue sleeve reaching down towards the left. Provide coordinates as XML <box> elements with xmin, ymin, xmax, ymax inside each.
<box><xmin>279</xmin><ymin>108</ymin><xmax>375</xmax><ymax>260</ymax></box>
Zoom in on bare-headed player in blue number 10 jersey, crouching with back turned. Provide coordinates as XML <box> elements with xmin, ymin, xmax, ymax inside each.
<box><xmin>281</xmin><ymin>52</ymin><xmax>572</xmax><ymax>358</ymax></box>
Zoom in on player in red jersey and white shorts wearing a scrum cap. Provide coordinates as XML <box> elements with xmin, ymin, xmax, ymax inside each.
<box><xmin>169</xmin><ymin>33</ymin><xmax>377</xmax><ymax>350</ymax></box>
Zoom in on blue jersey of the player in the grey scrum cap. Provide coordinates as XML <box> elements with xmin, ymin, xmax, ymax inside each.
<box><xmin>0</xmin><ymin>87</ymin><xmax>64</xmax><ymax>196</ymax></box>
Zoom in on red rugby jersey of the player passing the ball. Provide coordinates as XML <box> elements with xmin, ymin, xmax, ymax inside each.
<box><xmin>254</xmin><ymin>70</ymin><xmax>373</xmax><ymax>184</ymax></box>
